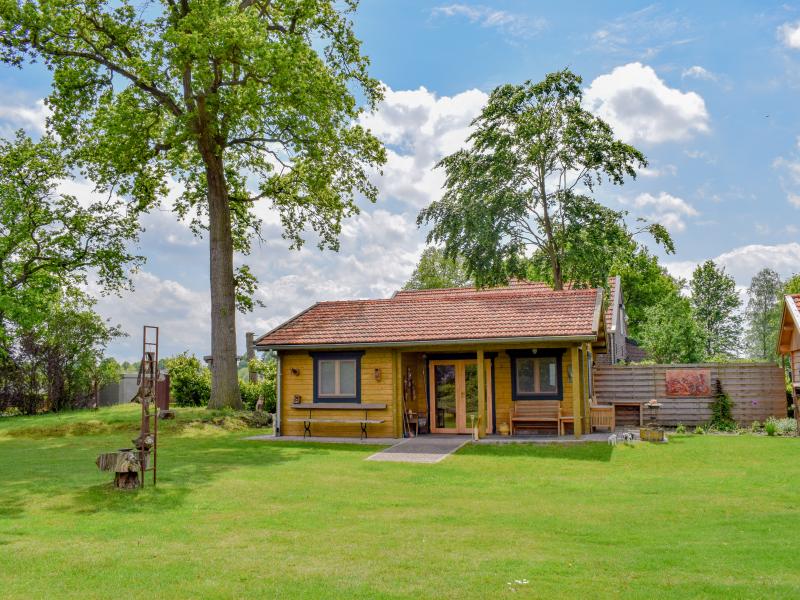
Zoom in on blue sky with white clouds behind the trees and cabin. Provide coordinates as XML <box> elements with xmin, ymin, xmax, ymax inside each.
<box><xmin>0</xmin><ymin>0</ymin><xmax>800</xmax><ymax>358</ymax></box>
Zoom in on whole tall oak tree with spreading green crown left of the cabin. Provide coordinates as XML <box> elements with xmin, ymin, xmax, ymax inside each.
<box><xmin>0</xmin><ymin>0</ymin><xmax>384</xmax><ymax>407</ymax></box>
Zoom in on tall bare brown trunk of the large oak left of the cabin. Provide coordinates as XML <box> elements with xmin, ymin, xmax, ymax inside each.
<box><xmin>204</xmin><ymin>155</ymin><xmax>242</xmax><ymax>409</ymax></box>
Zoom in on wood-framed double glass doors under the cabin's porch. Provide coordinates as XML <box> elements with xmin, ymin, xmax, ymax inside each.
<box><xmin>430</xmin><ymin>360</ymin><xmax>489</xmax><ymax>433</ymax></box>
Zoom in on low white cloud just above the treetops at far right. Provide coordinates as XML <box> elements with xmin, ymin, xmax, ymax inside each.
<box><xmin>664</xmin><ymin>242</ymin><xmax>800</xmax><ymax>287</ymax></box>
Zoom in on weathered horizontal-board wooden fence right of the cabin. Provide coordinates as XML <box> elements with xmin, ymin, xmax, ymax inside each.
<box><xmin>594</xmin><ymin>363</ymin><xmax>787</xmax><ymax>427</ymax></box>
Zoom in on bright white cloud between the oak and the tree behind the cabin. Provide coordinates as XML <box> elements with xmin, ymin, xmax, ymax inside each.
<box><xmin>361</xmin><ymin>87</ymin><xmax>488</xmax><ymax>209</ymax></box>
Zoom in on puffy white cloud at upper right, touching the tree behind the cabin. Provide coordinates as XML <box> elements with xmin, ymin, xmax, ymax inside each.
<box><xmin>584</xmin><ymin>62</ymin><xmax>709</xmax><ymax>144</ymax></box>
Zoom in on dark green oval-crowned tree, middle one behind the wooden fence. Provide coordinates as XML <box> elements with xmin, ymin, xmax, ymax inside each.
<box><xmin>689</xmin><ymin>260</ymin><xmax>742</xmax><ymax>356</ymax></box>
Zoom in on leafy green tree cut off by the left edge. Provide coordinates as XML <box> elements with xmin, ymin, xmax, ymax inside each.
<box><xmin>0</xmin><ymin>131</ymin><xmax>141</xmax><ymax>352</ymax></box>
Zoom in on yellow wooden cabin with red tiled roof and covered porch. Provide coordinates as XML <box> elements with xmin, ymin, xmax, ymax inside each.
<box><xmin>255</xmin><ymin>282</ymin><xmax>607</xmax><ymax>438</ymax></box>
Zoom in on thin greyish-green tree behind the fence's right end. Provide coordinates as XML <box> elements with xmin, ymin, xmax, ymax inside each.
<box><xmin>745</xmin><ymin>268</ymin><xmax>783</xmax><ymax>360</ymax></box>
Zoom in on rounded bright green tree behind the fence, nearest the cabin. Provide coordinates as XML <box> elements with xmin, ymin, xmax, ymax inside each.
<box><xmin>640</xmin><ymin>291</ymin><xmax>705</xmax><ymax>363</ymax></box>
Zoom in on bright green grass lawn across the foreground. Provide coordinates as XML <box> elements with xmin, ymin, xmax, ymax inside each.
<box><xmin>0</xmin><ymin>406</ymin><xmax>800</xmax><ymax>600</ymax></box>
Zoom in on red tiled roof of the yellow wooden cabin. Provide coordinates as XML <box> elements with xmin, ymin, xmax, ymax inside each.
<box><xmin>256</xmin><ymin>282</ymin><xmax>602</xmax><ymax>347</ymax></box>
